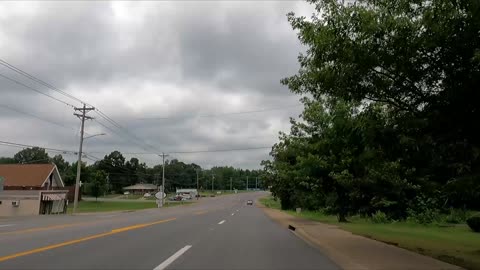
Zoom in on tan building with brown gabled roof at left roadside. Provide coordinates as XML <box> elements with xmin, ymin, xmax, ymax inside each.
<box><xmin>0</xmin><ymin>164</ymin><xmax>68</xmax><ymax>216</ymax></box>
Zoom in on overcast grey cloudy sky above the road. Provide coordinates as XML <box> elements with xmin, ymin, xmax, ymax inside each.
<box><xmin>0</xmin><ymin>1</ymin><xmax>313</xmax><ymax>168</ymax></box>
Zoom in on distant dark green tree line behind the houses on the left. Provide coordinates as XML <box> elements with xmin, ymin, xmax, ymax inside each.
<box><xmin>0</xmin><ymin>147</ymin><xmax>264</xmax><ymax>196</ymax></box>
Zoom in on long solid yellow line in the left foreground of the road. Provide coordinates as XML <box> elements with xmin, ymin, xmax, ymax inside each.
<box><xmin>0</xmin><ymin>218</ymin><xmax>176</xmax><ymax>262</ymax></box>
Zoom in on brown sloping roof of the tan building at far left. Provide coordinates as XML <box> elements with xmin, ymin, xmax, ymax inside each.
<box><xmin>0</xmin><ymin>164</ymin><xmax>56</xmax><ymax>187</ymax></box>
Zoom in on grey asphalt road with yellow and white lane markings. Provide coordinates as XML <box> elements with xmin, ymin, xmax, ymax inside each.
<box><xmin>0</xmin><ymin>192</ymin><xmax>338</xmax><ymax>270</ymax></box>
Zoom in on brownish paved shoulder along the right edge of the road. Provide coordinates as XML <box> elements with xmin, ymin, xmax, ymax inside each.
<box><xmin>257</xmin><ymin>204</ymin><xmax>462</xmax><ymax>270</ymax></box>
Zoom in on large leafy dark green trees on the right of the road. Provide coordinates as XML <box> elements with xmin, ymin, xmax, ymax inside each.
<box><xmin>262</xmin><ymin>0</ymin><xmax>480</xmax><ymax>222</ymax></box>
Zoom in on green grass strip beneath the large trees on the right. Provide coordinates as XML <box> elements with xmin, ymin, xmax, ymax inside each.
<box><xmin>260</xmin><ymin>198</ymin><xmax>480</xmax><ymax>270</ymax></box>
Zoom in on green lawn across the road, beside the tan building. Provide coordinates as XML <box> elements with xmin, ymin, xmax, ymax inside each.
<box><xmin>67</xmin><ymin>201</ymin><xmax>192</xmax><ymax>213</ymax></box>
